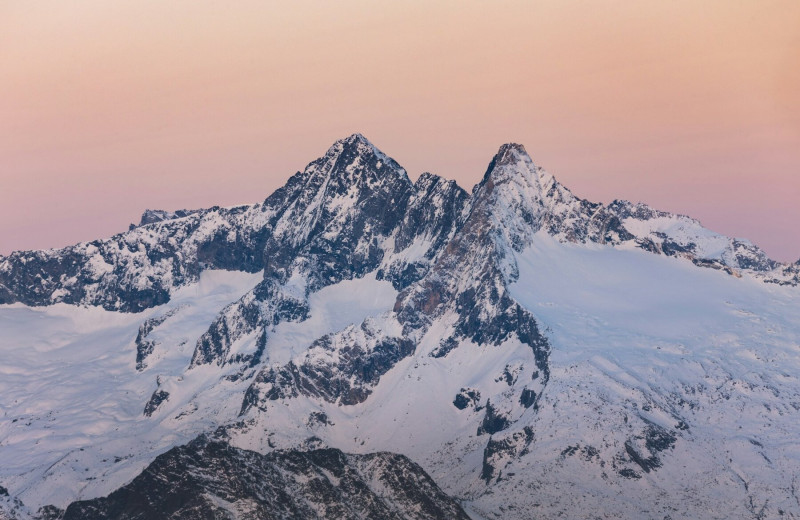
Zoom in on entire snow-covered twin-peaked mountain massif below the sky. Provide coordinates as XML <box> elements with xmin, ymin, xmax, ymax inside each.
<box><xmin>0</xmin><ymin>134</ymin><xmax>800</xmax><ymax>518</ymax></box>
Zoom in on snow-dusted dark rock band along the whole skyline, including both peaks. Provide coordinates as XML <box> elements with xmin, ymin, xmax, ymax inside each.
<box><xmin>0</xmin><ymin>134</ymin><xmax>800</xmax><ymax>320</ymax></box>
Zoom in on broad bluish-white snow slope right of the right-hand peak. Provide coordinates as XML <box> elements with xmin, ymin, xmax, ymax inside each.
<box><xmin>495</xmin><ymin>234</ymin><xmax>800</xmax><ymax>518</ymax></box>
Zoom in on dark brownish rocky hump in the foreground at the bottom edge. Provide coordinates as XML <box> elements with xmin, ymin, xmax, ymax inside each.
<box><xmin>54</xmin><ymin>436</ymin><xmax>469</xmax><ymax>520</ymax></box>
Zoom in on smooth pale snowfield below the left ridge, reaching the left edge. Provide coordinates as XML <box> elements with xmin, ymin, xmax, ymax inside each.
<box><xmin>0</xmin><ymin>271</ymin><xmax>260</xmax><ymax>505</ymax></box>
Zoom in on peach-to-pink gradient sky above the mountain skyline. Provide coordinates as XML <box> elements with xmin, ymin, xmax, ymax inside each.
<box><xmin>0</xmin><ymin>0</ymin><xmax>800</xmax><ymax>261</ymax></box>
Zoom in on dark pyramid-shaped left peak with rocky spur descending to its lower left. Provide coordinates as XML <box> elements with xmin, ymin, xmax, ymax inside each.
<box><xmin>192</xmin><ymin>135</ymin><xmax>454</xmax><ymax>365</ymax></box>
